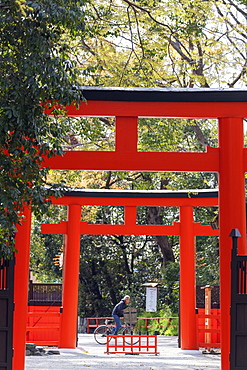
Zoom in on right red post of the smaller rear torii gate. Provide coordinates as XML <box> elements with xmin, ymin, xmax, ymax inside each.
<box><xmin>180</xmin><ymin>206</ymin><xmax>198</xmax><ymax>350</ymax></box>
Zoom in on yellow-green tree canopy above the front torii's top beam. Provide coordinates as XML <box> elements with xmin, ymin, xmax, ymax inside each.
<box><xmin>79</xmin><ymin>0</ymin><xmax>247</xmax><ymax>87</ymax></box>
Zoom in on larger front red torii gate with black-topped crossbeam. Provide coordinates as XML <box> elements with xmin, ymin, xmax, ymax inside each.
<box><xmin>14</xmin><ymin>87</ymin><xmax>247</xmax><ymax>370</ymax></box>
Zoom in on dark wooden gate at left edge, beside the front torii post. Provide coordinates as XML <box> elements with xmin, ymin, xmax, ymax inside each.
<box><xmin>0</xmin><ymin>258</ymin><xmax>14</xmax><ymax>370</ymax></box>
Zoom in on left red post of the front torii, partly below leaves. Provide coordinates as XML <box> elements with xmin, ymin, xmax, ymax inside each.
<box><xmin>13</xmin><ymin>207</ymin><xmax>31</xmax><ymax>370</ymax></box>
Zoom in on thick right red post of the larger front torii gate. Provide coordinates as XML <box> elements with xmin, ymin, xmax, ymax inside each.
<box><xmin>219</xmin><ymin>118</ymin><xmax>246</xmax><ymax>370</ymax></box>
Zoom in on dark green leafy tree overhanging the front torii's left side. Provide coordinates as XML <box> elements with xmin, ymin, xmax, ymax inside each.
<box><xmin>0</xmin><ymin>0</ymin><xmax>85</xmax><ymax>257</ymax></box>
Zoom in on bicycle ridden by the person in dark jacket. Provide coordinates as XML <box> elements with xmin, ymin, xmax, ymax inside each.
<box><xmin>94</xmin><ymin>320</ymin><xmax>138</xmax><ymax>345</ymax></box>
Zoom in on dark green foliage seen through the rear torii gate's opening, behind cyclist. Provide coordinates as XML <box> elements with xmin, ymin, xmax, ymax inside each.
<box><xmin>79</xmin><ymin>207</ymin><xmax>179</xmax><ymax>317</ymax></box>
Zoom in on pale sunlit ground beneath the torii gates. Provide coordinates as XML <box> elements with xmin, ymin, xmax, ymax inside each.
<box><xmin>25</xmin><ymin>334</ymin><xmax>220</xmax><ymax>370</ymax></box>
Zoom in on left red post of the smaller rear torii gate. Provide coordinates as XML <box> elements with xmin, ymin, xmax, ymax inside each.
<box><xmin>59</xmin><ymin>204</ymin><xmax>81</xmax><ymax>348</ymax></box>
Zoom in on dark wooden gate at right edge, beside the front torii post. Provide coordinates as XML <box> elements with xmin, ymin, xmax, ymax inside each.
<box><xmin>231</xmin><ymin>229</ymin><xmax>247</xmax><ymax>370</ymax></box>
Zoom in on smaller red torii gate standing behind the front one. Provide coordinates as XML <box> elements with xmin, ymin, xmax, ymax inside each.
<box><xmin>42</xmin><ymin>190</ymin><xmax>218</xmax><ymax>350</ymax></box>
